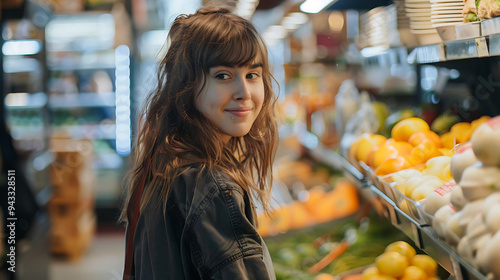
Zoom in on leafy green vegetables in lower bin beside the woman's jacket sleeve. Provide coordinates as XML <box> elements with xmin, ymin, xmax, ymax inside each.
<box><xmin>265</xmin><ymin>214</ymin><xmax>410</xmax><ymax>280</ymax></box>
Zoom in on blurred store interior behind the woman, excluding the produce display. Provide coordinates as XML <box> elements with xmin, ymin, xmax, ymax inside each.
<box><xmin>0</xmin><ymin>0</ymin><xmax>500</xmax><ymax>280</ymax></box>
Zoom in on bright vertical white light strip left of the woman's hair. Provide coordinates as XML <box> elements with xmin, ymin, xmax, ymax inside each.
<box><xmin>115</xmin><ymin>45</ymin><xmax>131</xmax><ymax>156</ymax></box>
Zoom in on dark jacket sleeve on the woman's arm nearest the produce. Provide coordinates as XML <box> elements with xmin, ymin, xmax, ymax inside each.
<box><xmin>189</xmin><ymin>184</ymin><xmax>275</xmax><ymax>280</ymax></box>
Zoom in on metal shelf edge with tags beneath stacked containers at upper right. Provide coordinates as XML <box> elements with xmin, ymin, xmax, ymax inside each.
<box><xmin>408</xmin><ymin>34</ymin><xmax>494</xmax><ymax>64</ymax></box>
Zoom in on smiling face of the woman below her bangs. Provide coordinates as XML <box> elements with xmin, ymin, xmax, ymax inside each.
<box><xmin>195</xmin><ymin>63</ymin><xmax>264</xmax><ymax>143</ymax></box>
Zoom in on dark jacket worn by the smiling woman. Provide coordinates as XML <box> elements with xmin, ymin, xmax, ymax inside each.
<box><xmin>132</xmin><ymin>165</ymin><xmax>276</xmax><ymax>280</ymax></box>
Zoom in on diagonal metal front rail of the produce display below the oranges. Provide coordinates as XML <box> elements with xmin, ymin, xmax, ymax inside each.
<box><xmin>302</xmin><ymin>141</ymin><xmax>490</xmax><ymax>280</ymax></box>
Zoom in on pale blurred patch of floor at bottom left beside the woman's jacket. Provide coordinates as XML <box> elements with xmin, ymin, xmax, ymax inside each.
<box><xmin>50</xmin><ymin>233</ymin><xmax>125</xmax><ymax>280</ymax></box>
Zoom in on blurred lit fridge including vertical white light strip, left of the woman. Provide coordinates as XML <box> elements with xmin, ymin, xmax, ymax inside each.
<box><xmin>46</xmin><ymin>12</ymin><xmax>131</xmax><ymax>209</ymax></box>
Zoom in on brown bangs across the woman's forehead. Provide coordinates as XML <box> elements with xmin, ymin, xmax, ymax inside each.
<box><xmin>205</xmin><ymin>27</ymin><xmax>265</xmax><ymax>71</ymax></box>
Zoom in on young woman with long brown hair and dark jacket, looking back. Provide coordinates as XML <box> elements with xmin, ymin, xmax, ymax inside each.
<box><xmin>122</xmin><ymin>5</ymin><xmax>277</xmax><ymax>280</ymax></box>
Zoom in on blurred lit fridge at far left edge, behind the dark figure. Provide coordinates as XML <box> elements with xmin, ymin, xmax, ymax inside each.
<box><xmin>2</xmin><ymin>19</ymin><xmax>50</xmax><ymax>204</ymax></box>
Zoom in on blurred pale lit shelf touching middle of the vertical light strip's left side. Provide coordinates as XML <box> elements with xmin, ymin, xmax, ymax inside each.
<box><xmin>49</xmin><ymin>92</ymin><xmax>115</xmax><ymax>109</ymax></box>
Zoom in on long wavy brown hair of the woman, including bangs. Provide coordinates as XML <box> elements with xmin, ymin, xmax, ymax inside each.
<box><xmin>121</xmin><ymin>7</ymin><xmax>278</xmax><ymax>221</ymax></box>
